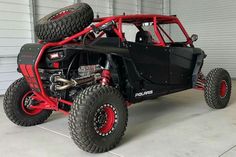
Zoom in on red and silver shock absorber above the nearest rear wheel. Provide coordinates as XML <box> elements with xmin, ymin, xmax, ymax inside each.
<box><xmin>101</xmin><ymin>55</ymin><xmax>111</xmax><ymax>85</ymax></box>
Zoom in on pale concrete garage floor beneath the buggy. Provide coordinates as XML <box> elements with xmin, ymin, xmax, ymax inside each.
<box><xmin>0</xmin><ymin>82</ymin><xmax>236</xmax><ymax>157</ymax></box>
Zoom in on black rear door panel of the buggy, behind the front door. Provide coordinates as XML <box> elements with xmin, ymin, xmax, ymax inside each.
<box><xmin>128</xmin><ymin>42</ymin><xmax>169</xmax><ymax>84</ymax></box>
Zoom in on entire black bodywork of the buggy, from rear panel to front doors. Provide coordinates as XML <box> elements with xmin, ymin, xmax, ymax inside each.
<box><xmin>15</xmin><ymin>37</ymin><xmax>206</xmax><ymax>102</ymax></box>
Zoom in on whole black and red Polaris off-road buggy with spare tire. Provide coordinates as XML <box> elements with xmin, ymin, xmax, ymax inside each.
<box><xmin>4</xmin><ymin>3</ymin><xmax>231</xmax><ymax>153</ymax></box>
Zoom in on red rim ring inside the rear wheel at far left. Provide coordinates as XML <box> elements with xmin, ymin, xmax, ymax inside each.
<box><xmin>21</xmin><ymin>91</ymin><xmax>43</xmax><ymax>116</ymax></box>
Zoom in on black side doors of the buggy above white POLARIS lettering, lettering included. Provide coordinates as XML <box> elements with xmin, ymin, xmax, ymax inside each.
<box><xmin>125</xmin><ymin>42</ymin><xmax>204</xmax><ymax>102</ymax></box>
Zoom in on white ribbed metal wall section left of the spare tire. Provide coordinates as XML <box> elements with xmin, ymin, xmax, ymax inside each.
<box><xmin>0</xmin><ymin>0</ymin><xmax>32</xmax><ymax>95</ymax></box>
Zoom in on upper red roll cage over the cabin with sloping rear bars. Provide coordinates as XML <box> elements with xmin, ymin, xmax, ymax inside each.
<box><xmin>40</xmin><ymin>14</ymin><xmax>193</xmax><ymax>48</ymax></box>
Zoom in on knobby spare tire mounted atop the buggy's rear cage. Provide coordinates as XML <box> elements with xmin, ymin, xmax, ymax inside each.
<box><xmin>35</xmin><ymin>3</ymin><xmax>94</xmax><ymax>42</ymax></box>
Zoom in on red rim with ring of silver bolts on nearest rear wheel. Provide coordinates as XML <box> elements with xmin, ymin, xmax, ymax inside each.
<box><xmin>94</xmin><ymin>104</ymin><xmax>117</xmax><ymax>136</ymax></box>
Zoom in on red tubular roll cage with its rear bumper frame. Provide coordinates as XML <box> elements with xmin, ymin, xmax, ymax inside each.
<box><xmin>25</xmin><ymin>14</ymin><xmax>192</xmax><ymax>114</ymax></box>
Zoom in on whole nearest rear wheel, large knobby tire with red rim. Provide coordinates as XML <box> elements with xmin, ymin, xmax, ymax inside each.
<box><xmin>69</xmin><ymin>85</ymin><xmax>128</xmax><ymax>153</ymax></box>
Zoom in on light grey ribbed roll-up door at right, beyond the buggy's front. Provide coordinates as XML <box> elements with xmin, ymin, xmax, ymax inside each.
<box><xmin>171</xmin><ymin>0</ymin><xmax>236</xmax><ymax>78</ymax></box>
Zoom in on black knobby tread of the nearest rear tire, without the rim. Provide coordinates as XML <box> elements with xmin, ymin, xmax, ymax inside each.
<box><xmin>69</xmin><ymin>85</ymin><xmax>128</xmax><ymax>153</ymax></box>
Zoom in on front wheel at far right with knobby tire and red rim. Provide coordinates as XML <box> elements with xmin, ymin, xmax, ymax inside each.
<box><xmin>204</xmin><ymin>68</ymin><xmax>232</xmax><ymax>109</ymax></box>
